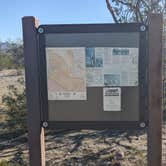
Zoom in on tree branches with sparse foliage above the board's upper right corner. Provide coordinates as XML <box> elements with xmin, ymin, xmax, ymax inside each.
<box><xmin>106</xmin><ymin>0</ymin><xmax>166</xmax><ymax>23</ymax></box>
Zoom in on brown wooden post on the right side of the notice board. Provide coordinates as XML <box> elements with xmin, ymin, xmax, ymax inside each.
<box><xmin>148</xmin><ymin>14</ymin><xmax>162</xmax><ymax>166</ymax></box>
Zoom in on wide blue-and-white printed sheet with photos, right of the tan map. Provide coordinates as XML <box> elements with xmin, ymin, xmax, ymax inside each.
<box><xmin>86</xmin><ymin>47</ymin><xmax>138</xmax><ymax>87</ymax></box>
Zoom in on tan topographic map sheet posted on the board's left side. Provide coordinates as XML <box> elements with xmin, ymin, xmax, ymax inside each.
<box><xmin>46</xmin><ymin>47</ymin><xmax>86</xmax><ymax>100</ymax></box>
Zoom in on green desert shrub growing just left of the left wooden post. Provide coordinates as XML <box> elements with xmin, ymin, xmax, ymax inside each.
<box><xmin>2</xmin><ymin>79</ymin><xmax>27</xmax><ymax>132</ymax></box>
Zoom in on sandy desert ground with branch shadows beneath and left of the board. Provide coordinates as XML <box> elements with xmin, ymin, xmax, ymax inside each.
<box><xmin>0</xmin><ymin>70</ymin><xmax>166</xmax><ymax>166</ymax></box>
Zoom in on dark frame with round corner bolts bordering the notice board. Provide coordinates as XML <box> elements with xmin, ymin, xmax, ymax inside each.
<box><xmin>38</xmin><ymin>23</ymin><xmax>148</xmax><ymax>130</ymax></box>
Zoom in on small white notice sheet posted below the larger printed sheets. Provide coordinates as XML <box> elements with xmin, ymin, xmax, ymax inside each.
<box><xmin>103</xmin><ymin>88</ymin><xmax>121</xmax><ymax>111</ymax></box>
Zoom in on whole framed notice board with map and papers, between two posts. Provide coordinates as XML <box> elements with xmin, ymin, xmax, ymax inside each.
<box><xmin>35</xmin><ymin>24</ymin><xmax>148</xmax><ymax>129</ymax></box>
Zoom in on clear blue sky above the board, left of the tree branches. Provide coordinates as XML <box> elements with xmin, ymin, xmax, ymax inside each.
<box><xmin>0</xmin><ymin>0</ymin><xmax>112</xmax><ymax>42</ymax></box>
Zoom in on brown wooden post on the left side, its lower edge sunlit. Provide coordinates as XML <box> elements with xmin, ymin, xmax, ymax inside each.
<box><xmin>22</xmin><ymin>16</ymin><xmax>45</xmax><ymax>166</ymax></box>
